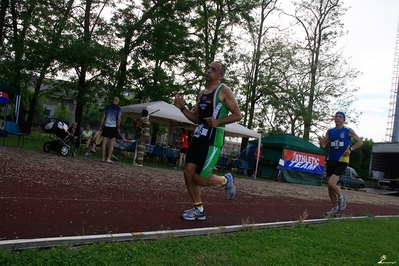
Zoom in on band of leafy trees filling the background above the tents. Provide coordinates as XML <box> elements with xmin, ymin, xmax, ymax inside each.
<box><xmin>0</xmin><ymin>0</ymin><xmax>359</xmax><ymax>148</ymax></box>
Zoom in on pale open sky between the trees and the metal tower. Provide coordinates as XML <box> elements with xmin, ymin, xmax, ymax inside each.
<box><xmin>338</xmin><ymin>0</ymin><xmax>399</xmax><ymax>142</ymax></box>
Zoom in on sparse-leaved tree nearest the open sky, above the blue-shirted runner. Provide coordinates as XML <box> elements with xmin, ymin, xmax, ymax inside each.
<box><xmin>289</xmin><ymin>0</ymin><xmax>358</xmax><ymax>139</ymax></box>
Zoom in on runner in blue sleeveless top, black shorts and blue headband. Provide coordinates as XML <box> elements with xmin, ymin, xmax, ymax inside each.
<box><xmin>320</xmin><ymin>112</ymin><xmax>363</xmax><ymax>216</ymax></box>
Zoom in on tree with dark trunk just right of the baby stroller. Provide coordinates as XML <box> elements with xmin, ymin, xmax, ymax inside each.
<box><xmin>67</xmin><ymin>0</ymin><xmax>119</xmax><ymax>127</ymax></box>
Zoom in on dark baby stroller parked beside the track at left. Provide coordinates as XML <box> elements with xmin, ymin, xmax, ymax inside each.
<box><xmin>43</xmin><ymin>118</ymin><xmax>73</xmax><ymax>156</ymax></box>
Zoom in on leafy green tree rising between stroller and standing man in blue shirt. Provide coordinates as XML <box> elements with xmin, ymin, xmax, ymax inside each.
<box><xmin>58</xmin><ymin>0</ymin><xmax>117</xmax><ymax>128</ymax></box>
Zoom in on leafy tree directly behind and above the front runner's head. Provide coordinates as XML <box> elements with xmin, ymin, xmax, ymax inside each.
<box><xmin>187</xmin><ymin>0</ymin><xmax>258</xmax><ymax>94</ymax></box>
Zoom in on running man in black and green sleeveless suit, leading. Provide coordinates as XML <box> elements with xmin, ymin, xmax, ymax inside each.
<box><xmin>174</xmin><ymin>62</ymin><xmax>241</xmax><ymax>220</ymax></box>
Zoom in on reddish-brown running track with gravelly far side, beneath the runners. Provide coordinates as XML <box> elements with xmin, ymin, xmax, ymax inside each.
<box><xmin>0</xmin><ymin>146</ymin><xmax>399</xmax><ymax>240</ymax></box>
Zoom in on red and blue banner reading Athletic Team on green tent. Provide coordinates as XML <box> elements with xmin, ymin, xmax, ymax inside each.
<box><xmin>283</xmin><ymin>149</ymin><xmax>325</xmax><ymax>175</ymax></box>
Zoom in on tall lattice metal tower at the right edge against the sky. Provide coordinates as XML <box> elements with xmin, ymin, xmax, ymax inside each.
<box><xmin>385</xmin><ymin>17</ymin><xmax>399</xmax><ymax>142</ymax></box>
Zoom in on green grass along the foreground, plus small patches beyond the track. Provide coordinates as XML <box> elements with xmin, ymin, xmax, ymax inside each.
<box><xmin>0</xmin><ymin>133</ymin><xmax>399</xmax><ymax>265</ymax></box>
